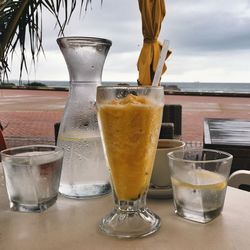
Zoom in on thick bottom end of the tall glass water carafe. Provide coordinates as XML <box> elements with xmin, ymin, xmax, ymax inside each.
<box><xmin>59</xmin><ymin>183</ymin><xmax>111</xmax><ymax>199</ymax></box>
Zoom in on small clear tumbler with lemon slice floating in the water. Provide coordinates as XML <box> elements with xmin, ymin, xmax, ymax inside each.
<box><xmin>168</xmin><ymin>149</ymin><xmax>233</xmax><ymax>223</ymax></box>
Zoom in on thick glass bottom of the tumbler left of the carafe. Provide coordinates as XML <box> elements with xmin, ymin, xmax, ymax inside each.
<box><xmin>10</xmin><ymin>196</ymin><xmax>57</xmax><ymax>213</ymax></box>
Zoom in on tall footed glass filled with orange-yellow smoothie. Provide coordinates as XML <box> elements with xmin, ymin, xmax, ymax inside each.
<box><xmin>96</xmin><ymin>87</ymin><xmax>163</xmax><ymax>238</ymax></box>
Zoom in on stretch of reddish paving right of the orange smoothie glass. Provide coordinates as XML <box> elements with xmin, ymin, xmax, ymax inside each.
<box><xmin>165</xmin><ymin>95</ymin><xmax>250</xmax><ymax>145</ymax></box>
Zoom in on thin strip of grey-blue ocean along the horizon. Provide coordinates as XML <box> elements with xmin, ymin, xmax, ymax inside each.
<box><xmin>8</xmin><ymin>80</ymin><xmax>250</xmax><ymax>94</ymax></box>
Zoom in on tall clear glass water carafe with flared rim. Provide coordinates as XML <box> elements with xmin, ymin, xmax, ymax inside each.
<box><xmin>57</xmin><ymin>37</ymin><xmax>112</xmax><ymax>199</ymax></box>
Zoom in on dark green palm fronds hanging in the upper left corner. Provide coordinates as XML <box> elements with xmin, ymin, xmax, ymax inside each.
<box><xmin>0</xmin><ymin>0</ymin><xmax>99</xmax><ymax>82</ymax></box>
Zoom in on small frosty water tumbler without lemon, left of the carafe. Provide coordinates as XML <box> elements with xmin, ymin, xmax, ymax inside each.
<box><xmin>1</xmin><ymin>145</ymin><xmax>63</xmax><ymax>212</ymax></box>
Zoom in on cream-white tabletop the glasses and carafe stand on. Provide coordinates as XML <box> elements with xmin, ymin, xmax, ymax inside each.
<box><xmin>0</xmin><ymin>164</ymin><xmax>250</xmax><ymax>250</ymax></box>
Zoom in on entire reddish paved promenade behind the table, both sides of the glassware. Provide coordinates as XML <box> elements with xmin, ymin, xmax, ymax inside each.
<box><xmin>0</xmin><ymin>89</ymin><xmax>250</xmax><ymax>147</ymax></box>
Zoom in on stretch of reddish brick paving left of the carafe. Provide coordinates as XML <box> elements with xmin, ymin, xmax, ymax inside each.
<box><xmin>0</xmin><ymin>89</ymin><xmax>68</xmax><ymax>147</ymax></box>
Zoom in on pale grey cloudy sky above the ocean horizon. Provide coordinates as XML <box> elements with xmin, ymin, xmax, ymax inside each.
<box><xmin>6</xmin><ymin>0</ymin><xmax>250</xmax><ymax>83</ymax></box>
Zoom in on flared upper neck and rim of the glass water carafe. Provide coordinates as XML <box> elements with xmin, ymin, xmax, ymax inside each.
<box><xmin>57</xmin><ymin>37</ymin><xmax>112</xmax><ymax>84</ymax></box>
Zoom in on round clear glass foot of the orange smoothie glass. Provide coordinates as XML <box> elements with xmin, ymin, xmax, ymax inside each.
<box><xmin>99</xmin><ymin>208</ymin><xmax>161</xmax><ymax>238</ymax></box>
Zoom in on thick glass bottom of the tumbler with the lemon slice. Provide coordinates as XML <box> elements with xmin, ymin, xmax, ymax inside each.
<box><xmin>175</xmin><ymin>205</ymin><xmax>222</xmax><ymax>223</ymax></box>
